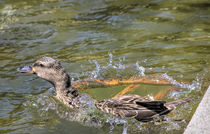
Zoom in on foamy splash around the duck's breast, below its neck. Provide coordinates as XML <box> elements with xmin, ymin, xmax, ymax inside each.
<box><xmin>24</xmin><ymin>94</ymin><xmax>103</xmax><ymax>127</ymax></box>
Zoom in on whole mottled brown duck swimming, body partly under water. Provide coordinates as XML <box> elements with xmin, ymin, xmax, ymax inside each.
<box><xmin>17</xmin><ymin>57</ymin><xmax>190</xmax><ymax>122</ymax></box>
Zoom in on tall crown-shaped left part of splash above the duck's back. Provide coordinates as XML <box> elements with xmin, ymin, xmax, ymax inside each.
<box><xmin>79</xmin><ymin>53</ymin><xmax>146</xmax><ymax>82</ymax></box>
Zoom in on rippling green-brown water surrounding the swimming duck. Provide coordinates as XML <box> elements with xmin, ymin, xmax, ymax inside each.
<box><xmin>0</xmin><ymin>0</ymin><xmax>210</xmax><ymax>134</ymax></box>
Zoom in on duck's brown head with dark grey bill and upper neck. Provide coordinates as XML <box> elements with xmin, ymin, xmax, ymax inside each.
<box><xmin>17</xmin><ymin>57</ymin><xmax>71</xmax><ymax>90</ymax></box>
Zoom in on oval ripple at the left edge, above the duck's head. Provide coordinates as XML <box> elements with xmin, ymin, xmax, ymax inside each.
<box><xmin>0</xmin><ymin>24</ymin><xmax>56</xmax><ymax>45</ymax></box>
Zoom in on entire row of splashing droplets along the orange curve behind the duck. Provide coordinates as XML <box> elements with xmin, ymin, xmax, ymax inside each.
<box><xmin>72</xmin><ymin>53</ymin><xmax>204</xmax><ymax>96</ymax></box>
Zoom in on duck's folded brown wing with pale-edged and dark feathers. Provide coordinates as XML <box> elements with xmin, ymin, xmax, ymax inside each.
<box><xmin>96</xmin><ymin>95</ymin><xmax>171</xmax><ymax>121</ymax></box>
